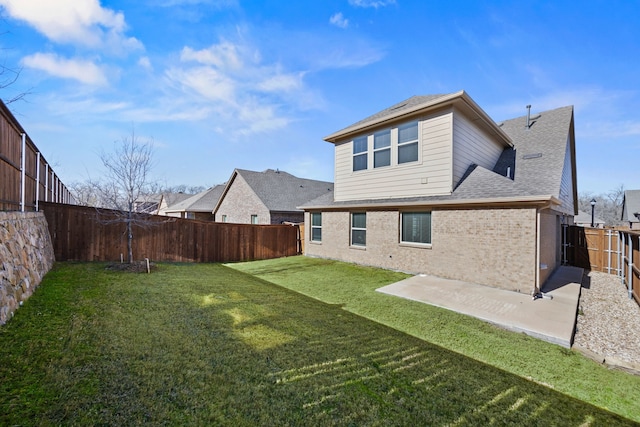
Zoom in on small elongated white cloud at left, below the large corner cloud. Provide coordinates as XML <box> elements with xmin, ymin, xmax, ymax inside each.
<box><xmin>21</xmin><ymin>53</ymin><xmax>107</xmax><ymax>86</ymax></box>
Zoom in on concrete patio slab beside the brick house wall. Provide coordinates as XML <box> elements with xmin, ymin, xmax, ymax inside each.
<box><xmin>377</xmin><ymin>266</ymin><xmax>583</xmax><ymax>348</ymax></box>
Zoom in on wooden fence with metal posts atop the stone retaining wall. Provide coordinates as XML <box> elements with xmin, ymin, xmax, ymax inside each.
<box><xmin>0</xmin><ymin>101</ymin><xmax>75</xmax><ymax>211</ymax></box>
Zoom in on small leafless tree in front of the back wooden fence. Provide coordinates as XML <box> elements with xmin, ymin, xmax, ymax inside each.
<box><xmin>92</xmin><ymin>129</ymin><xmax>153</xmax><ymax>263</ymax></box>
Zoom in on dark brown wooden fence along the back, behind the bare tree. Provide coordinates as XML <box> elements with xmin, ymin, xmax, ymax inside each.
<box><xmin>40</xmin><ymin>203</ymin><xmax>299</xmax><ymax>262</ymax></box>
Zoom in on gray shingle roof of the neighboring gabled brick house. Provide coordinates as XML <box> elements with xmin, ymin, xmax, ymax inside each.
<box><xmin>235</xmin><ymin>169</ymin><xmax>333</xmax><ymax>212</ymax></box>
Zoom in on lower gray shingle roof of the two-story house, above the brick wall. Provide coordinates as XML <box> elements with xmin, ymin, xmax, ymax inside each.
<box><xmin>302</xmin><ymin>106</ymin><xmax>576</xmax><ymax>209</ymax></box>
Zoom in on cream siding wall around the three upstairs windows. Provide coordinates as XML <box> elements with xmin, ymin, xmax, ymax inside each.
<box><xmin>334</xmin><ymin>110</ymin><xmax>452</xmax><ymax>201</ymax></box>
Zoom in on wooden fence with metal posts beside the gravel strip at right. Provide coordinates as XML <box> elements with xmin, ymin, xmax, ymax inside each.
<box><xmin>565</xmin><ymin>226</ymin><xmax>640</xmax><ymax>304</ymax></box>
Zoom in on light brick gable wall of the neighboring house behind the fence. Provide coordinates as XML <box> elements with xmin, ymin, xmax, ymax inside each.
<box><xmin>216</xmin><ymin>175</ymin><xmax>271</xmax><ymax>224</ymax></box>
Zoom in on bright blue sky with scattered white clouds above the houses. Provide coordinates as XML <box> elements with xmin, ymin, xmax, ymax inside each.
<box><xmin>0</xmin><ymin>0</ymin><xmax>640</xmax><ymax>193</ymax></box>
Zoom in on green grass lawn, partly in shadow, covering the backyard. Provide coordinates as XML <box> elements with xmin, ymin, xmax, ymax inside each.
<box><xmin>0</xmin><ymin>257</ymin><xmax>639</xmax><ymax>426</ymax></box>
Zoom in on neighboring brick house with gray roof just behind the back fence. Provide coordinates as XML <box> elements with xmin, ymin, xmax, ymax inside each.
<box><xmin>213</xmin><ymin>169</ymin><xmax>333</xmax><ymax>224</ymax></box>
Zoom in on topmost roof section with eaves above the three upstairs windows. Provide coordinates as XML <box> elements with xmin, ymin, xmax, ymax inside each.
<box><xmin>324</xmin><ymin>90</ymin><xmax>511</xmax><ymax>150</ymax></box>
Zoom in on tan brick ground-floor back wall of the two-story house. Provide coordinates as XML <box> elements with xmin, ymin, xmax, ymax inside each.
<box><xmin>305</xmin><ymin>208</ymin><xmax>536</xmax><ymax>293</ymax></box>
